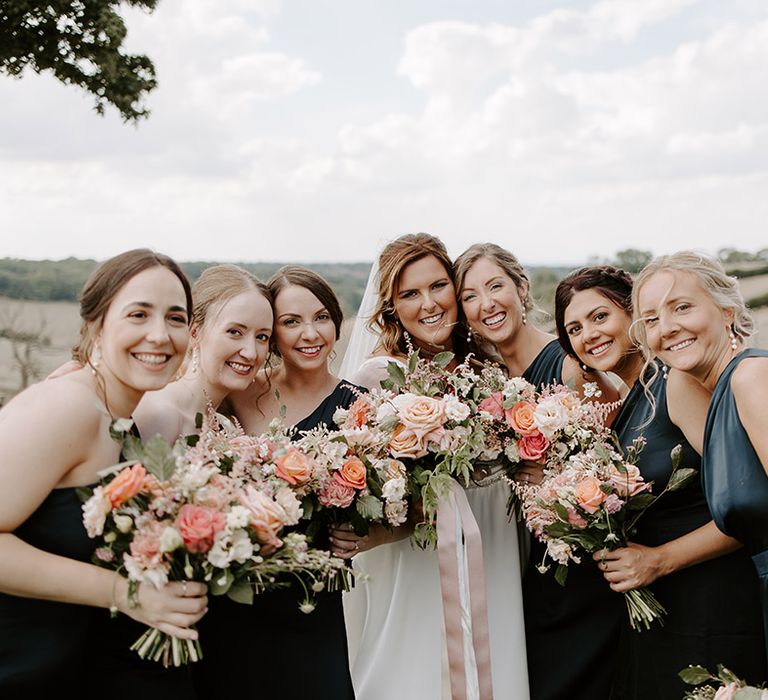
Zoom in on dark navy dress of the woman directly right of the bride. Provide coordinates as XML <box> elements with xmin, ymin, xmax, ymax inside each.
<box><xmin>523</xmin><ymin>340</ymin><xmax>626</xmax><ymax>700</ymax></box>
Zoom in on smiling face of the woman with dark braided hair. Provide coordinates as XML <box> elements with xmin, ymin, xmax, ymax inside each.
<box><xmin>563</xmin><ymin>287</ymin><xmax>638</xmax><ymax>376</ymax></box>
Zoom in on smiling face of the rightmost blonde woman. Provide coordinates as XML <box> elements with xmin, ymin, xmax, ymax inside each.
<box><xmin>638</xmin><ymin>270</ymin><xmax>733</xmax><ymax>381</ymax></box>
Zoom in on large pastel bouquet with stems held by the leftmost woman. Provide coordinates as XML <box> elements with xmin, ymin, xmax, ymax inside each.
<box><xmin>83</xmin><ymin>414</ymin><xmax>343</xmax><ymax>666</ymax></box>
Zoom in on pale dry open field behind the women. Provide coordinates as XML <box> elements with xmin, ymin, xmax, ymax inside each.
<box><xmin>0</xmin><ymin>275</ymin><xmax>768</xmax><ymax>405</ymax></box>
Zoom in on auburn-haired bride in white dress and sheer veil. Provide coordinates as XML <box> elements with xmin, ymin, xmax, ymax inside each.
<box><xmin>332</xmin><ymin>234</ymin><xmax>529</xmax><ymax>700</ymax></box>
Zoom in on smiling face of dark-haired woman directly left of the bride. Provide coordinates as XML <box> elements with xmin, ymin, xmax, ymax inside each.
<box><xmin>274</xmin><ymin>285</ymin><xmax>336</xmax><ymax>371</ymax></box>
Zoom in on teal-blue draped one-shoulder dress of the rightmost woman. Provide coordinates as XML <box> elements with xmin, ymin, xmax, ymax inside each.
<box><xmin>702</xmin><ymin>348</ymin><xmax>768</xmax><ymax>668</ymax></box>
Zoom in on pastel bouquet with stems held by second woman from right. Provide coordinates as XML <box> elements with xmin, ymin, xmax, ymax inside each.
<box><xmin>515</xmin><ymin>438</ymin><xmax>696</xmax><ymax>630</ymax></box>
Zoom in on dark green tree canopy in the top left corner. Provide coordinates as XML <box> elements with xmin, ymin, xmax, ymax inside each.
<box><xmin>0</xmin><ymin>0</ymin><xmax>157</xmax><ymax>122</ymax></box>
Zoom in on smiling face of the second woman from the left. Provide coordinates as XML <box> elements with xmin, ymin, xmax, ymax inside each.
<box><xmin>194</xmin><ymin>289</ymin><xmax>272</xmax><ymax>393</ymax></box>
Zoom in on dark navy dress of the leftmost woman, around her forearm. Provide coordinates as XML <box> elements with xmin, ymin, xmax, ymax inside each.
<box><xmin>0</xmin><ymin>488</ymin><xmax>99</xmax><ymax>700</ymax></box>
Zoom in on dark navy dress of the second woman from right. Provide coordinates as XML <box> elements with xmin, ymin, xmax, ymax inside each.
<box><xmin>611</xmin><ymin>368</ymin><xmax>765</xmax><ymax>700</ymax></box>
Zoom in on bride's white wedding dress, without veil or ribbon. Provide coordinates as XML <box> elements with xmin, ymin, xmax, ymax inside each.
<box><xmin>344</xmin><ymin>357</ymin><xmax>529</xmax><ymax>700</ymax></box>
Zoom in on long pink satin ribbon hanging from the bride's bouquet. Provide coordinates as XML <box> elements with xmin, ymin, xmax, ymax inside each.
<box><xmin>437</xmin><ymin>482</ymin><xmax>493</xmax><ymax>700</ymax></box>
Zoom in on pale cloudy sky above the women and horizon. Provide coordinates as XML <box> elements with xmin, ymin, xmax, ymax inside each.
<box><xmin>0</xmin><ymin>0</ymin><xmax>768</xmax><ymax>264</ymax></box>
